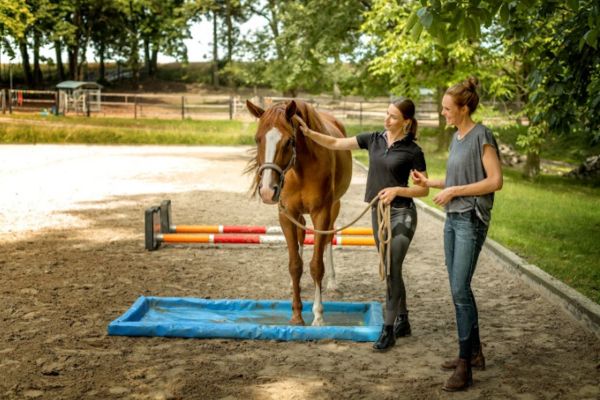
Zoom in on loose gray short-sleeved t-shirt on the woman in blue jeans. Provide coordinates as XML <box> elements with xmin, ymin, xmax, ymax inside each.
<box><xmin>445</xmin><ymin>124</ymin><xmax>500</xmax><ymax>225</ymax></box>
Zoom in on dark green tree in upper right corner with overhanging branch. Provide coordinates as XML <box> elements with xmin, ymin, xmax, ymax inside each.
<box><xmin>407</xmin><ymin>0</ymin><xmax>600</xmax><ymax>176</ymax></box>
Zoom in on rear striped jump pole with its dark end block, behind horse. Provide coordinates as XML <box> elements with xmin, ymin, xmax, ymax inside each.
<box><xmin>160</xmin><ymin>200</ymin><xmax>373</xmax><ymax>236</ymax></box>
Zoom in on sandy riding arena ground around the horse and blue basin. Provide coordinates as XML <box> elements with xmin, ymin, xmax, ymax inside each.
<box><xmin>0</xmin><ymin>145</ymin><xmax>600</xmax><ymax>399</ymax></box>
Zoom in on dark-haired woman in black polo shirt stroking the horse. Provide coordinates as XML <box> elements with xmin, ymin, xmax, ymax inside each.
<box><xmin>300</xmin><ymin>99</ymin><xmax>429</xmax><ymax>351</ymax></box>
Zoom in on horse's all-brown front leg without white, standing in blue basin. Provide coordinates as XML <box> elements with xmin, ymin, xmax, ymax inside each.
<box><xmin>279</xmin><ymin>209</ymin><xmax>304</xmax><ymax>325</ymax></box>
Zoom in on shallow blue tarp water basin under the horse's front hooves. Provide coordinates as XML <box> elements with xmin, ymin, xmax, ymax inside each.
<box><xmin>108</xmin><ymin>296</ymin><xmax>383</xmax><ymax>342</ymax></box>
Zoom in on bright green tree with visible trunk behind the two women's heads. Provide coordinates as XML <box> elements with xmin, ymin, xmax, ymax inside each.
<box><xmin>362</xmin><ymin>0</ymin><xmax>506</xmax><ymax>150</ymax></box>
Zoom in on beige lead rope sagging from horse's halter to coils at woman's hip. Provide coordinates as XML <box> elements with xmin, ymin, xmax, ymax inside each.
<box><xmin>278</xmin><ymin>196</ymin><xmax>392</xmax><ymax>280</ymax></box>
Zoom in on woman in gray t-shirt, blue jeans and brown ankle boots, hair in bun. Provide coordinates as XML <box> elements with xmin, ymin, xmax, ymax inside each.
<box><xmin>411</xmin><ymin>78</ymin><xmax>502</xmax><ymax>391</ymax></box>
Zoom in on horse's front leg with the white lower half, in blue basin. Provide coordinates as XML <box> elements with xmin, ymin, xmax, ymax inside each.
<box><xmin>310</xmin><ymin>210</ymin><xmax>333</xmax><ymax>326</ymax></box>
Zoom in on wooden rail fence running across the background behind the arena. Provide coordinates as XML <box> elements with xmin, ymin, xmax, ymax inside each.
<box><xmin>0</xmin><ymin>89</ymin><xmax>516</xmax><ymax>126</ymax></box>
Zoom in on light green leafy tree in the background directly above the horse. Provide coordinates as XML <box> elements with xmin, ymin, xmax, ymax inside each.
<box><xmin>245</xmin><ymin>0</ymin><xmax>369</xmax><ymax>96</ymax></box>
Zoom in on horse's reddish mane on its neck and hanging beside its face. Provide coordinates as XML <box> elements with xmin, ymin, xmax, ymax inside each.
<box><xmin>244</xmin><ymin>100</ymin><xmax>338</xmax><ymax>197</ymax></box>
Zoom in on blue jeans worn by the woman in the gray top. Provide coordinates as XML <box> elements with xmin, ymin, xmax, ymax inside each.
<box><xmin>444</xmin><ymin>211</ymin><xmax>488</xmax><ymax>358</ymax></box>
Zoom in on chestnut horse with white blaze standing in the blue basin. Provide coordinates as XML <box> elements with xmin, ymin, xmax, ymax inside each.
<box><xmin>246</xmin><ymin>100</ymin><xmax>352</xmax><ymax>326</ymax></box>
